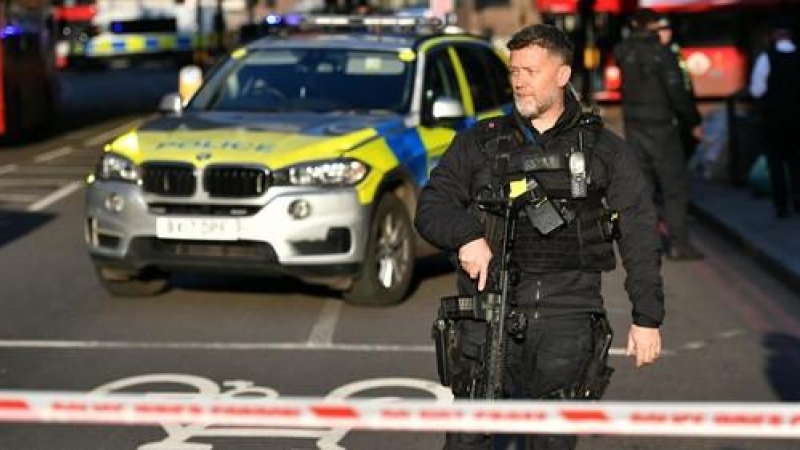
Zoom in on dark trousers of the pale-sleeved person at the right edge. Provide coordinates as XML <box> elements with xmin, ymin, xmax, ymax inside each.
<box><xmin>765</xmin><ymin>118</ymin><xmax>800</xmax><ymax>214</ymax></box>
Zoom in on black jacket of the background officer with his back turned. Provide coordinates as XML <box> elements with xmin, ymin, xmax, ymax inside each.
<box><xmin>614</xmin><ymin>32</ymin><xmax>702</xmax><ymax>128</ymax></box>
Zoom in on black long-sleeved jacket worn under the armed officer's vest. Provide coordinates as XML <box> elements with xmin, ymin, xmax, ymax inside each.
<box><xmin>415</xmin><ymin>96</ymin><xmax>664</xmax><ymax>327</ymax></box>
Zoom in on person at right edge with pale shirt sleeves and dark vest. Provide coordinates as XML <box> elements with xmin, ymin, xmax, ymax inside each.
<box><xmin>749</xmin><ymin>16</ymin><xmax>800</xmax><ymax>219</ymax></box>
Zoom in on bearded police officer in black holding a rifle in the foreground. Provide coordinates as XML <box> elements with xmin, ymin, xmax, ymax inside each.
<box><xmin>415</xmin><ymin>25</ymin><xmax>664</xmax><ymax>450</ymax></box>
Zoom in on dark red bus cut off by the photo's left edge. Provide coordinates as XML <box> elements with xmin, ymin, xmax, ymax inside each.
<box><xmin>0</xmin><ymin>0</ymin><xmax>58</xmax><ymax>139</ymax></box>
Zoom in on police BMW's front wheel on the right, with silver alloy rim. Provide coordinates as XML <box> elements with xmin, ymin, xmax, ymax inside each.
<box><xmin>344</xmin><ymin>194</ymin><xmax>415</xmax><ymax>306</ymax></box>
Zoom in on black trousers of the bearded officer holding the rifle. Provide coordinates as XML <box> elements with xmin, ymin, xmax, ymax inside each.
<box><xmin>444</xmin><ymin>309</ymin><xmax>593</xmax><ymax>450</ymax></box>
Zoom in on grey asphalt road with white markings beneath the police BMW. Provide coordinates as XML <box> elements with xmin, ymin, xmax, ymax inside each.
<box><xmin>0</xmin><ymin>70</ymin><xmax>800</xmax><ymax>450</ymax></box>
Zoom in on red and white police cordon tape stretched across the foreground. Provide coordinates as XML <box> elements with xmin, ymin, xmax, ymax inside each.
<box><xmin>0</xmin><ymin>391</ymin><xmax>800</xmax><ymax>438</ymax></box>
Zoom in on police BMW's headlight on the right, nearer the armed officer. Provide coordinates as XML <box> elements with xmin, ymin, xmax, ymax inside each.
<box><xmin>275</xmin><ymin>159</ymin><xmax>369</xmax><ymax>186</ymax></box>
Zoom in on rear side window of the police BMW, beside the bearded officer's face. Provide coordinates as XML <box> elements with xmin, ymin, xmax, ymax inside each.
<box><xmin>456</xmin><ymin>45</ymin><xmax>512</xmax><ymax>112</ymax></box>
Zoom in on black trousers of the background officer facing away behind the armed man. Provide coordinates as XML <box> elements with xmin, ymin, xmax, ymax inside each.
<box><xmin>625</xmin><ymin>121</ymin><xmax>690</xmax><ymax>246</ymax></box>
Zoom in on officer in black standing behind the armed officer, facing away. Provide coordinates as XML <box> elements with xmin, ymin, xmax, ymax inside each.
<box><xmin>614</xmin><ymin>9</ymin><xmax>703</xmax><ymax>260</ymax></box>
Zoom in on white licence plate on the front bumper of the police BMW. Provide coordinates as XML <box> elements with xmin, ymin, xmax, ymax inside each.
<box><xmin>156</xmin><ymin>217</ymin><xmax>239</xmax><ymax>241</ymax></box>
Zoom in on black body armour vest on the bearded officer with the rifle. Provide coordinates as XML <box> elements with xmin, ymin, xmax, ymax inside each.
<box><xmin>481</xmin><ymin>114</ymin><xmax>616</xmax><ymax>273</ymax></box>
